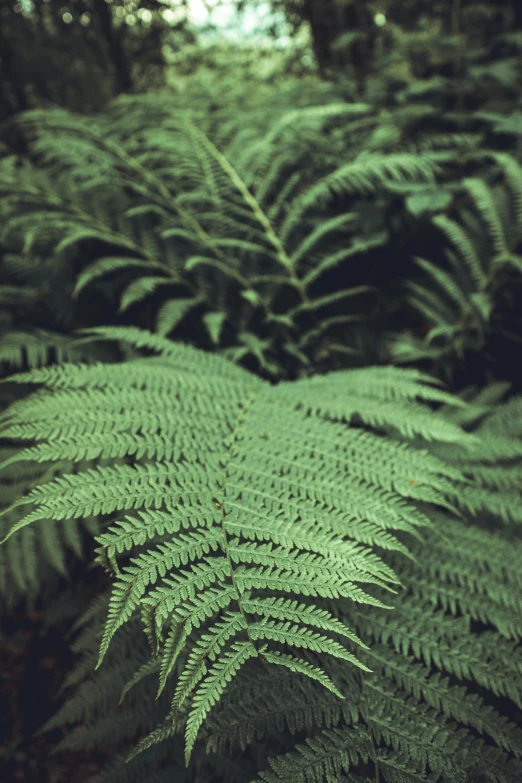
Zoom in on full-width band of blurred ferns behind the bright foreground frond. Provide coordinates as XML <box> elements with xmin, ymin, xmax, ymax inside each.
<box><xmin>0</xmin><ymin>86</ymin><xmax>521</xmax><ymax>388</ymax></box>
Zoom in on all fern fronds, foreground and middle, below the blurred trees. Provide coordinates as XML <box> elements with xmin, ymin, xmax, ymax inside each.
<box><xmin>0</xmin><ymin>87</ymin><xmax>522</xmax><ymax>783</ymax></box>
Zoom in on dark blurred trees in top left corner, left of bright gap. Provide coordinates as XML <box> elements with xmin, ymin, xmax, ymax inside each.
<box><xmin>0</xmin><ymin>0</ymin><xmax>185</xmax><ymax>116</ymax></box>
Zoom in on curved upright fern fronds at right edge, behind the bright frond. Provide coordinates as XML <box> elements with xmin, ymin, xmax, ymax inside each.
<box><xmin>388</xmin><ymin>151</ymin><xmax>522</xmax><ymax>376</ymax></box>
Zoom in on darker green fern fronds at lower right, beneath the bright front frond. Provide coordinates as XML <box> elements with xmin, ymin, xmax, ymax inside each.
<box><xmin>208</xmin><ymin>384</ymin><xmax>522</xmax><ymax>783</ymax></box>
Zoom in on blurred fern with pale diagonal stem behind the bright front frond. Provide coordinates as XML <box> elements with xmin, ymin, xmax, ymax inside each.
<box><xmin>3</xmin><ymin>96</ymin><xmax>452</xmax><ymax>377</ymax></box>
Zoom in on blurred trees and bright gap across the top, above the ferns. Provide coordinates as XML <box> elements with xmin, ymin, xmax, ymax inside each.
<box><xmin>0</xmin><ymin>0</ymin><xmax>522</xmax><ymax>116</ymax></box>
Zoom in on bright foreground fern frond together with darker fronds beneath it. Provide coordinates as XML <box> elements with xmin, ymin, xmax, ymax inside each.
<box><xmin>2</xmin><ymin>329</ymin><xmax>522</xmax><ymax>783</ymax></box>
